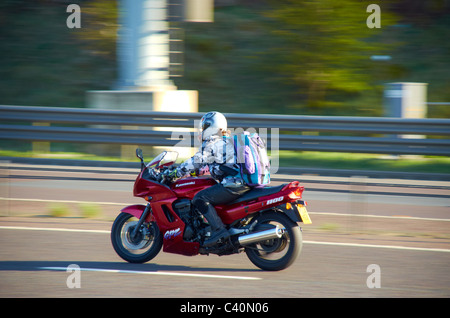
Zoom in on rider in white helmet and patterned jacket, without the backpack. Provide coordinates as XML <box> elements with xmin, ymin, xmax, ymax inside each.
<box><xmin>165</xmin><ymin>112</ymin><xmax>250</xmax><ymax>246</ymax></box>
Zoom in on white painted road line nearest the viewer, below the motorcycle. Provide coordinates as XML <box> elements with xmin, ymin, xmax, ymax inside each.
<box><xmin>39</xmin><ymin>267</ymin><xmax>262</xmax><ymax>280</ymax></box>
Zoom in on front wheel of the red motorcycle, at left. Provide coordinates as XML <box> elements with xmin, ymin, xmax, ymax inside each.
<box><xmin>111</xmin><ymin>212</ymin><xmax>163</xmax><ymax>263</ymax></box>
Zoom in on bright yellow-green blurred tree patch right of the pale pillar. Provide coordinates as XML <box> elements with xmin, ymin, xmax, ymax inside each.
<box><xmin>267</xmin><ymin>0</ymin><xmax>395</xmax><ymax>110</ymax></box>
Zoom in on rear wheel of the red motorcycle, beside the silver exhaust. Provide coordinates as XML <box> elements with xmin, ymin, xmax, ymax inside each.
<box><xmin>245</xmin><ymin>212</ymin><xmax>303</xmax><ymax>271</ymax></box>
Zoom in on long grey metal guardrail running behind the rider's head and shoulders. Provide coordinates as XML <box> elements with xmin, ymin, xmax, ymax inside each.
<box><xmin>0</xmin><ymin>106</ymin><xmax>450</xmax><ymax>156</ymax></box>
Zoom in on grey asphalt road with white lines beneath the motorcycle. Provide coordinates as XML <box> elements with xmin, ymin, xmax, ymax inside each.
<box><xmin>0</xmin><ymin>167</ymin><xmax>450</xmax><ymax>298</ymax></box>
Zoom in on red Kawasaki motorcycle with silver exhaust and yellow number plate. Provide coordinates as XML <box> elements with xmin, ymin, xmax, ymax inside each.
<box><xmin>111</xmin><ymin>149</ymin><xmax>311</xmax><ymax>271</ymax></box>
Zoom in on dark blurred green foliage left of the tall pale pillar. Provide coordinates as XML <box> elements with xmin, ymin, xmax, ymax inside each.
<box><xmin>0</xmin><ymin>0</ymin><xmax>116</xmax><ymax>107</ymax></box>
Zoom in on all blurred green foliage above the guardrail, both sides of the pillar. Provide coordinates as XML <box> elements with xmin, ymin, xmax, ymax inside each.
<box><xmin>0</xmin><ymin>0</ymin><xmax>450</xmax><ymax>117</ymax></box>
